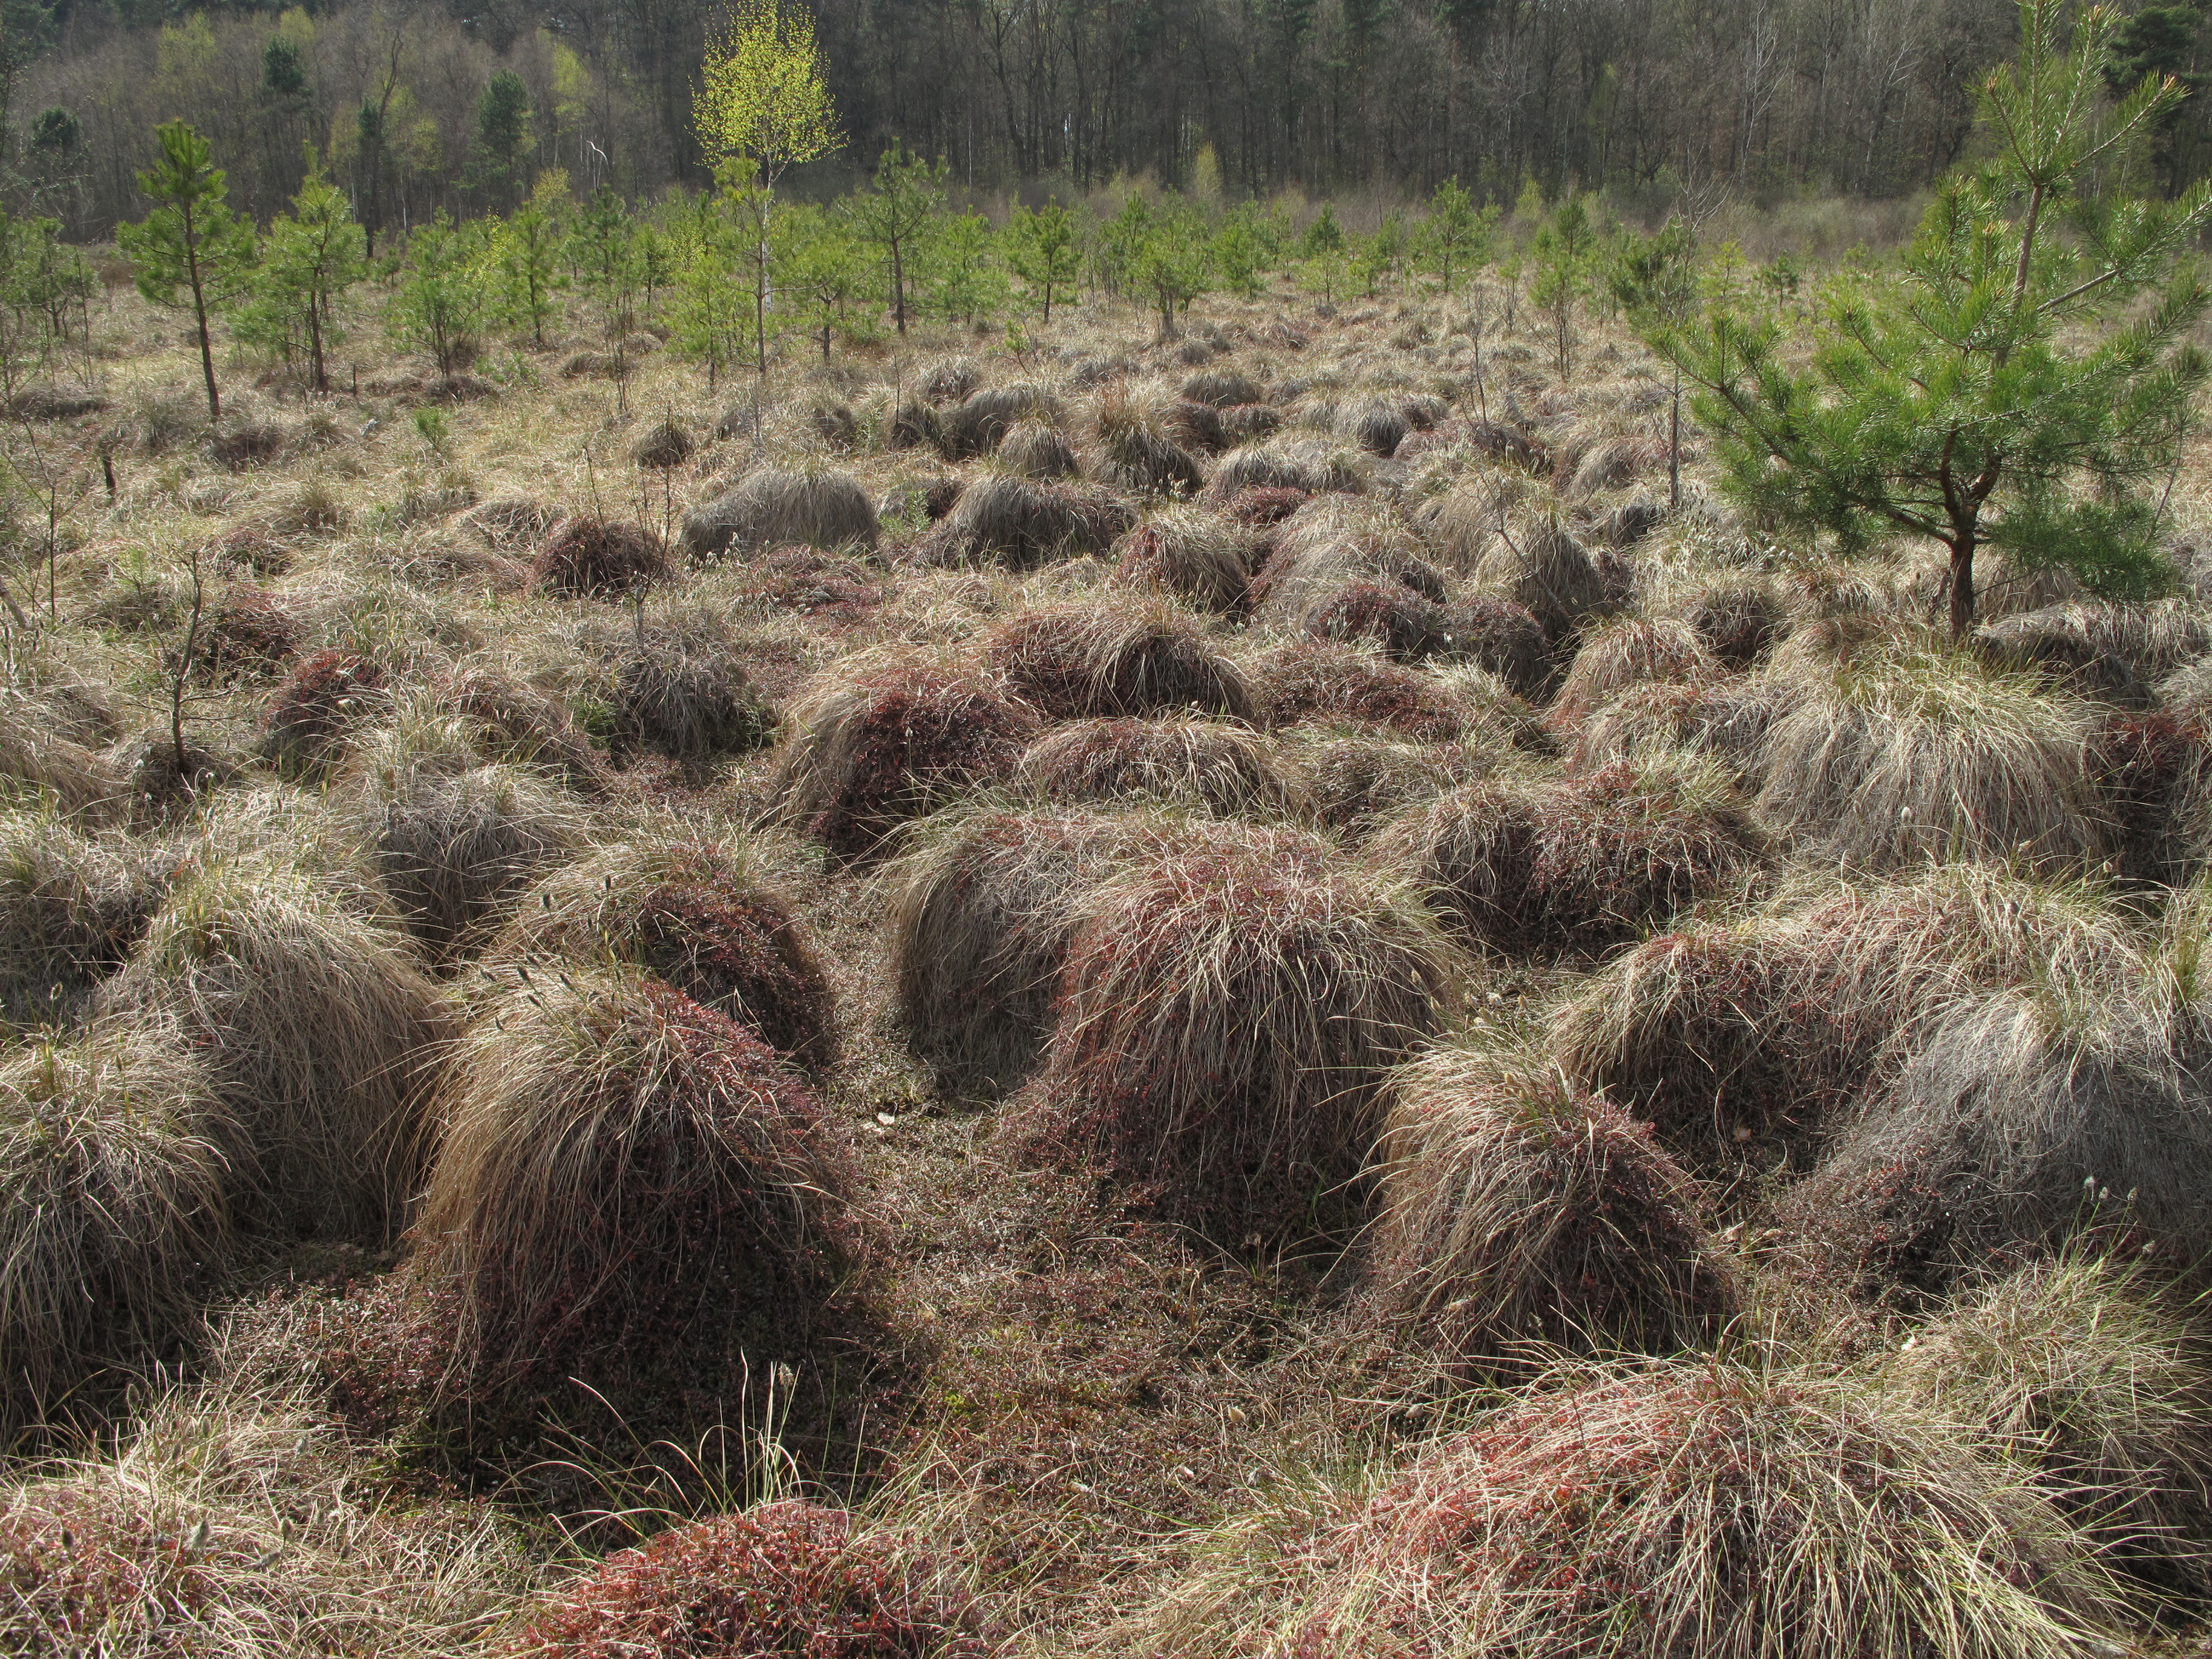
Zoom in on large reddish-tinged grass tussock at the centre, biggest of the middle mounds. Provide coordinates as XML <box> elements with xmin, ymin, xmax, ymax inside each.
<box><xmin>1017</xmin><ymin>825</ymin><xmax>1458</xmax><ymax>1241</ymax></box>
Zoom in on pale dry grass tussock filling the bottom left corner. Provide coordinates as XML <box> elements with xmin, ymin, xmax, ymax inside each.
<box><xmin>0</xmin><ymin>1385</ymin><xmax>542</xmax><ymax>1659</ymax></box>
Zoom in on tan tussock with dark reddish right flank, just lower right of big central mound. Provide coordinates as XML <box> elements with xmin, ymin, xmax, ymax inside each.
<box><xmin>1367</xmin><ymin>1046</ymin><xmax>1737</xmax><ymax>1374</ymax></box>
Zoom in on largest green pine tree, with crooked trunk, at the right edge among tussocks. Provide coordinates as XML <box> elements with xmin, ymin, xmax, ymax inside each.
<box><xmin>1652</xmin><ymin>0</ymin><xmax>2212</xmax><ymax>637</ymax></box>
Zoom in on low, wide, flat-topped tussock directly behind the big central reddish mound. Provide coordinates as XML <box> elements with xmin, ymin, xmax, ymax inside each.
<box><xmin>1016</xmin><ymin>719</ymin><xmax>1294</xmax><ymax>818</ymax></box>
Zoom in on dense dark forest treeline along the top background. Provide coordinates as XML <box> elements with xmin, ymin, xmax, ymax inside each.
<box><xmin>0</xmin><ymin>0</ymin><xmax>2205</xmax><ymax>236</ymax></box>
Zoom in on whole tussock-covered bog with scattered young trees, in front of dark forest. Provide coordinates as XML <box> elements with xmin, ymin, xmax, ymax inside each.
<box><xmin>0</xmin><ymin>0</ymin><xmax>2212</xmax><ymax>1659</ymax></box>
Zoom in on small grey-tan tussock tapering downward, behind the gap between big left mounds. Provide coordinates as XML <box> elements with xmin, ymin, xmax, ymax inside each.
<box><xmin>350</xmin><ymin>746</ymin><xmax>584</xmax><ymax>960</ymax></box>
